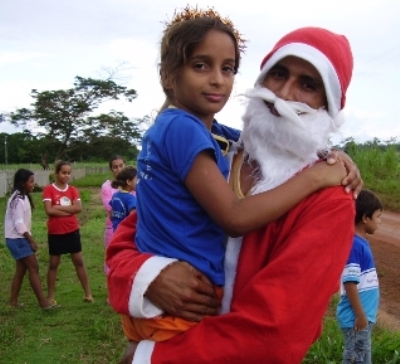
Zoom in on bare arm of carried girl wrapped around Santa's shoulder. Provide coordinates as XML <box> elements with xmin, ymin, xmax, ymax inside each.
<box><xmin>185</xmin><ymin>152</ymin><xmax>346</xmax><ymax>236</ymax></box>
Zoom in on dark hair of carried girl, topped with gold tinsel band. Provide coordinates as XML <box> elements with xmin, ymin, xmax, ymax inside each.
<box><xmin>159</xmin><ymin>7</ymin><xmax>245</xmax><ymax>111</ymax></box>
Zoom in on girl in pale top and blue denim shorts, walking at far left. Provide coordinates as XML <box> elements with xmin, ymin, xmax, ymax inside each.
<box><xmin>4</xmin><ymin>169</ymin><xmax>56</xmax><ymax>310</ymax></box>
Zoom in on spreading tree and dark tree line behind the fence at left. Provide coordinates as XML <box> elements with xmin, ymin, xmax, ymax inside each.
<box><xmin>0</xmin><ymin>76</ymin><xmax>149</xmax><ymax>169</ymax></box>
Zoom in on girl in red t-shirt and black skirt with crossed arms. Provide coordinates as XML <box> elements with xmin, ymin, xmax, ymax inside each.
<box><xmin>43</xmin><ymin>161</ymin><xmax>93</xmax><ymax>303</ymax></box>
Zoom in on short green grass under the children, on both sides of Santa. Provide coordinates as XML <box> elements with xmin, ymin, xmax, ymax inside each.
<box><xmin>0</xmin><ymin>175</ymin><xmax>400</xmax><ymax>364</ymax></box>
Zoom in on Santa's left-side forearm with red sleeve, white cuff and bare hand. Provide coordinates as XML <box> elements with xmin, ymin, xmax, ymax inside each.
<box><xmin>106</xmin><ymin>212</ymin><xmax>218</xmax><ymax>321</ymax></box>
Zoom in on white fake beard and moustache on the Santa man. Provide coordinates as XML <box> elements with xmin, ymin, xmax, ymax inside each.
<box><xmin>241</xmin><ymin>86</ymin><xmax>337</xmax><ymax>194</ymax></box>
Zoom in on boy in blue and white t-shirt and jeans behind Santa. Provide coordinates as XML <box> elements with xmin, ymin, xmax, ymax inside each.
<box><xmin>337</xmin><ymin>190</ymin><xmax>382</xmax><ymax>364</ymax></box>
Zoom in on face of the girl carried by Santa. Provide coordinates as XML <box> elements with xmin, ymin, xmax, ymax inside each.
<box><xmin>164</xmin><ymin>30</ymin><xmax>236</xmax><ymax>129</ymax></box>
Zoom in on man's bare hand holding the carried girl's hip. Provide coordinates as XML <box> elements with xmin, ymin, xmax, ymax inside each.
<box><xmin>145</xmin><ymin>262</ymin><xmax>219</xmax><ymax>321</ymax></box>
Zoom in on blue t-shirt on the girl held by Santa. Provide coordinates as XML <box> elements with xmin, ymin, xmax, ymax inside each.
<box><xmin>136</xmin><ymin>108</ymin><xmax>229</xmax><ymax>285</ymax></box>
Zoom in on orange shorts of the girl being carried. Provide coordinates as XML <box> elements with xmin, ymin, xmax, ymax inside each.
<box><xmin>121</xmin><ymin>287</ymin><xmax>223</xmax><ymax>342</ymax></box>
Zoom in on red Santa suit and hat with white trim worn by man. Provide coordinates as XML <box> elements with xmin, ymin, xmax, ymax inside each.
<box><xmin>107</xmin><ymin>28</ymin><xmax>354</xmax><ymax>364</ymax></box>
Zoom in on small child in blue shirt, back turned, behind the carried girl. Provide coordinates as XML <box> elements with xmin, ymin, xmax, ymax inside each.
<box><xmin>109</xmin><ymin>166</ymin><xmax>137</xmax><ymax>231</ymax></box>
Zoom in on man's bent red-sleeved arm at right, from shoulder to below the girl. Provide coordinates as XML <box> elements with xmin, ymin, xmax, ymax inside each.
<box><xmin>135</xmin><ymin>187</ymin><xmax>354</xmax><ymax>364</ymax></box>
